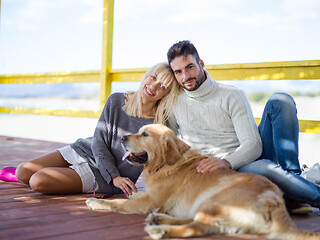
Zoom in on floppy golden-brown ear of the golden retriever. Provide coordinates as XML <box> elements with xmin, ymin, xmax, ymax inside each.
<box><xmin>161</xmin><ymin>134</ymin><xmax>190</xmax><ymax>165</ymax></box>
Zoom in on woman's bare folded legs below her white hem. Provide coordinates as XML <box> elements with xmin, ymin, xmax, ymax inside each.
<box><xmin>16</xmin><ymin>151</ymin><xmax>82</xmax><ymax>194</ymax></box>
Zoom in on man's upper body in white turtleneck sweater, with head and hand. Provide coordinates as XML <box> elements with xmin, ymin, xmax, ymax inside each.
<box><xmin>168</xmin><ymin>41</ymin><xmax>262</xmax><ymax>172</ymax></box>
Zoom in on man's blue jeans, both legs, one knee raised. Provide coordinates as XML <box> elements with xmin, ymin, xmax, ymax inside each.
<box><xmin>238</xmin><ymin>93</ymin><xmax>320</xmax><ymax>208</ymax></box>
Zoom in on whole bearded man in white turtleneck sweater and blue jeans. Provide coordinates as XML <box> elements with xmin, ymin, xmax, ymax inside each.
<box><xmin>167</xmin><ymin>41</ymin><xmax>320</xmax><ymax>213</ymax></box>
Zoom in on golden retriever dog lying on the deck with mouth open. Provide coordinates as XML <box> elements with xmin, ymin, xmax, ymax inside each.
<box><xmin>86</xmin><ymin>124</ymin><xmax>320</xmax><ymax>240</ymax></box>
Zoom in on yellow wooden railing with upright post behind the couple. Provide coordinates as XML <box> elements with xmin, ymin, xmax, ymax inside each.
<box><xmin>0</xmin><ymin>0</ymin><xmax>320</xmax><ymax>133</ymax></box>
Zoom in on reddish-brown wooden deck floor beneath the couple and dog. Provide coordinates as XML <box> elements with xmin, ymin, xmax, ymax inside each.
<box><xmin>0</xmin><ymin>136</ymin><xmax>320</xmax><ymax>240</ymax></box>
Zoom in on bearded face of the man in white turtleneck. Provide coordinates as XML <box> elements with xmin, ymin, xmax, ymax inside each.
<box><xmin>170</xmin><ymin>55</ymin><xmax>204</xmax><ymax>91</ymax></box>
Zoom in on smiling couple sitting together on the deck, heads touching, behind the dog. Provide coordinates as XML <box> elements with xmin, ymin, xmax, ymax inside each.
<box><xmin>12</xmin><ymin>41</ymin><xmax>320</xmax><ymax>213</ymax></box>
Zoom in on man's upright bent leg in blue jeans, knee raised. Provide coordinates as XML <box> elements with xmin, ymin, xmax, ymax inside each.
<box><xmin>259</xmin><ymin>93</ymin><xmax>301</xmax><ymax>174</ymax></box>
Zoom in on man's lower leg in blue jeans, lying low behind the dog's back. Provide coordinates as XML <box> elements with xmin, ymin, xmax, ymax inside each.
<box><xmin>238</xmin><ymin>159</ymin><xmax>320</xmax><ymax>208</ymax></box>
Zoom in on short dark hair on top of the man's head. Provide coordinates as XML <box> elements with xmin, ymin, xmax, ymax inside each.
<box><xmin>167</xmin><ymin>40</ymin><xmax>200</xmax><ymax>64</ymax></box>
